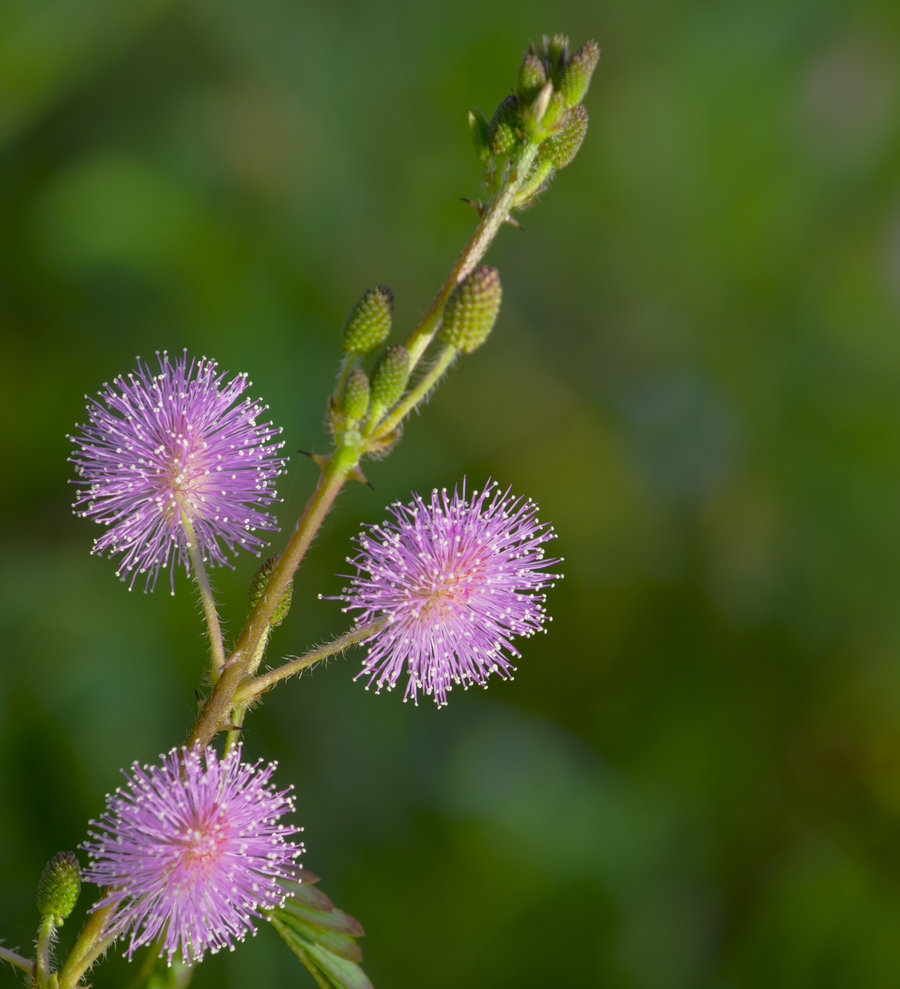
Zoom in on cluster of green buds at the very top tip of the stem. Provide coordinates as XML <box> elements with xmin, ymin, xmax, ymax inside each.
<box><xmin>469</xmin><ymin>34</ymin><xmax>600</xmax><ymax>209</ymax></box>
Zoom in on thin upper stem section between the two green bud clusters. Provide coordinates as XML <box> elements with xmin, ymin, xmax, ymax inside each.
<box><xmin>406</xmin><ymin>141</ymin><xmax>540</xmax><ymax>370</ymax></box>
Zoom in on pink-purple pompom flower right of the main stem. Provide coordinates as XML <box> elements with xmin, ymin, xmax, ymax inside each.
<box><xmin>330</xmin><ymin>482</ymin><xmax>560</xmax><ymax>707</ymax></box>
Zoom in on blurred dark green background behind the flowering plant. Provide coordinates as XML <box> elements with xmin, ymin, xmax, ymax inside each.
<box><xmin>0</xmin><ymin>0</ymin><xmax>900</xmax><ymax>989</ymax></box>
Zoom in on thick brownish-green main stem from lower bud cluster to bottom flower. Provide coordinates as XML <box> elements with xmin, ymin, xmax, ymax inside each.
<box><xmin>187</xmin><ymin>446</ymin><xmax>360</xmax><ymax>746</ymax></box>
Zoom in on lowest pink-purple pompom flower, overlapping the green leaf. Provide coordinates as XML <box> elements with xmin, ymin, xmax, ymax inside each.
<box><xmin>82</xmin><ymin>745</ymin><xmax>303</xmax><ymax>963</ymax></box>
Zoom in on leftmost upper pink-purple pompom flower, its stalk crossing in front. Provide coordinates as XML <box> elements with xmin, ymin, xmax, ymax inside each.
<box><xmin>69</xmin><ymin>352</ymin><xmax>285</xmax><ymax>590</ymax></box>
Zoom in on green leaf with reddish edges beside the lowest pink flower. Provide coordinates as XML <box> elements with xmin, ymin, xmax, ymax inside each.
<box><xmin>269</xmin><ymin>870</ymin><xmax>373</xmax><ymax>989</ymax></box>
